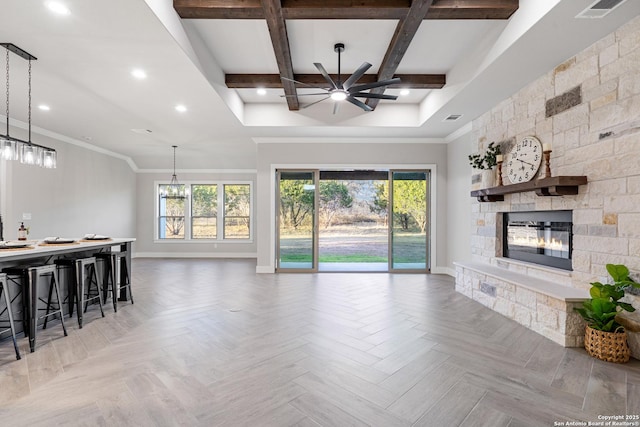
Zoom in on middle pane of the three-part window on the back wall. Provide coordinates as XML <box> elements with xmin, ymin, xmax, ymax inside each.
<box><xmin>191</xmin><ymin>184</ymin><xmax>218</xmax><ymax>239</ymax></box>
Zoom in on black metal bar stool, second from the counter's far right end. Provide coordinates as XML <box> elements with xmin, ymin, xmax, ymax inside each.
<box><xmin>54</xmin><ymin>257</ymin><xmax>104</xmax><ymax>329</ymax></box>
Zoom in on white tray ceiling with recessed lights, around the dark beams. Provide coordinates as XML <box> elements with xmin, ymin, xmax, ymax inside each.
<box><xmin>0</xmin><ymin>0</ymin><xmax>640</xmax><ymax>170</ymax></box>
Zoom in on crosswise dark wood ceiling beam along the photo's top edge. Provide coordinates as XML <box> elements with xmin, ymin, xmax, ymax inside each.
<box><xmin>173</xmin><ymin>0</ymin><xmax>519</xmax><ymax>19</ymax></box>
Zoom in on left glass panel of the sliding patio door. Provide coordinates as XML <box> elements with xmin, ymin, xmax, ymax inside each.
<box><xmin>276</xmin><ymin>170</ymin><xmax>318</xmax><ymax>271</ymax></box>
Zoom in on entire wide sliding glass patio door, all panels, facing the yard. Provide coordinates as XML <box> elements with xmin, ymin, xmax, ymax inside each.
<box><xmin>276</xmin><ymin>170</ymin><xmax>430</xmax><ymax>273</ymax></box>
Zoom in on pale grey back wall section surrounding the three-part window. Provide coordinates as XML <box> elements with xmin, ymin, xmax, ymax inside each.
<box><xmin>136</xmin><ymin>171</ymin><xmax>256</xmax><ymax>258</ymax></box>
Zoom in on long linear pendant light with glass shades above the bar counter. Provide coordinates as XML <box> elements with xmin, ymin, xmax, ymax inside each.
<box><xmin>0</xmin><ymin>43</ymin><xmax>58</xmax><ymax>169</ymax></box>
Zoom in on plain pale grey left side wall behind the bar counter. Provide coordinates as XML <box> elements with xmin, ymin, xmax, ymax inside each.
<box><xmin>0</xmin><ymin>130</ymin><xmax>136</xmax><ymax>241</ymax></box>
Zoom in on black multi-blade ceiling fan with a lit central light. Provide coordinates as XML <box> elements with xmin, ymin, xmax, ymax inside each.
<box><xmin>281</xmin><ymin>43</ymin><xmax>400</xmax><ymax>114</ymax></box>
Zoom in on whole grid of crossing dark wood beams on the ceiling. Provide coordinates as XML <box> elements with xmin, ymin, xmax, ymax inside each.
<box><xmin>173</xmin><ymin>0</ymin><xmax>518</xmax><ymax>111</ymax></box>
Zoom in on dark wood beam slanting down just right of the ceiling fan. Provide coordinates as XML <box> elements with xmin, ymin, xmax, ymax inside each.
<box><xmin>366</xmin><ymin>0</ymin><xmax>433</xmax><ymax>109</ymax></box>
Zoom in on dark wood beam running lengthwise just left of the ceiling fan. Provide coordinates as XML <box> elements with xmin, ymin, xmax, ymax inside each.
<box><xmin>261</xmin><ymin>0</ymin><xmax>300</xmax><ymax>111</ymax></box>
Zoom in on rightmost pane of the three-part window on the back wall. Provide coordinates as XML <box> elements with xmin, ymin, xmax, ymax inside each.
<box><xmin>224</xmin><ymin>184</ymin><xmax>251</xmax><ymax>239</ymax></box>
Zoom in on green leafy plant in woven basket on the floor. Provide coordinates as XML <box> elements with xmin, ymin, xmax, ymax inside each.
<box><xmin>574</xmin><ymin>264</ymin><xmax>640</xmax><ymax>363</ymax></box>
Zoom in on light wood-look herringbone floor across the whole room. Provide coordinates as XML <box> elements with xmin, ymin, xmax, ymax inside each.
<box><xmin>0</xmin><ymin>259</ymin><xmax>640</xmax><ymax>427</ymax></box>
